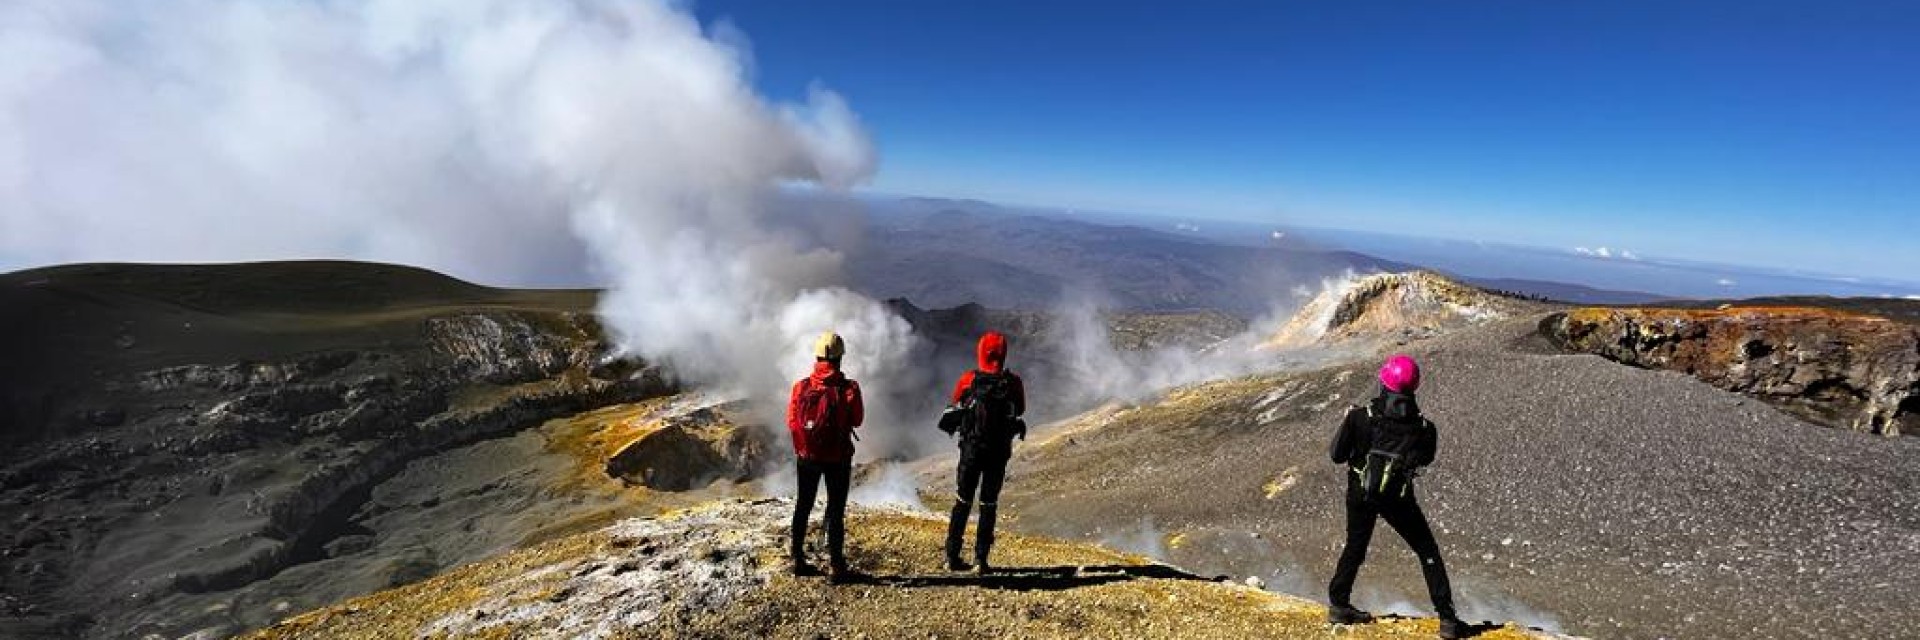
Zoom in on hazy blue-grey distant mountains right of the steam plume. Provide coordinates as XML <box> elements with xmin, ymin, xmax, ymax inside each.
<box><xmin>845</xmin><ymin>198</ymin><xmax>1663</xmax><ymax>317</ymax></box>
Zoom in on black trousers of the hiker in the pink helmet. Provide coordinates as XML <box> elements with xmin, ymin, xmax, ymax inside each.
<box><xmin>1327</xmin><ymin>490</ymin><xmax>1455</xmax><ymax>619</ymax></box>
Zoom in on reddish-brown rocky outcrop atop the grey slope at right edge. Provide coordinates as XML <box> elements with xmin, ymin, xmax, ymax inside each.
<box><xmin>1540</xmin><ymin>308</ymin><xmax>1920</xmax><ymax>436</ymax></box>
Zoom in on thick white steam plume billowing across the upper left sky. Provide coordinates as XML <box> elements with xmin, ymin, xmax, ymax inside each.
<box><xmin>0</xmin><ymin>0</ymin><xmax>914</xmax><ymax>446</ymax></box>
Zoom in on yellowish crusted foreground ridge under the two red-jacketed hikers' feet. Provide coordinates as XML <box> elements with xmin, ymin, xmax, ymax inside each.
<box><xmin>255</xmin><ymin>500</ymin><xmax>1549</xmax><ymax>640</ymax></box>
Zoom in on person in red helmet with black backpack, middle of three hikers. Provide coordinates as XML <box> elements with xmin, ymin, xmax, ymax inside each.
<box><xmin>941</xmin><ymin>331</ymin><xmax>1027</xmax><ymax>573</ymax></box>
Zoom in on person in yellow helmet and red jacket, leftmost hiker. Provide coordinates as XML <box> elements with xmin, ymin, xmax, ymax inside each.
<box><xmin>787</xmin><ymin>332</ymin><xmax>866</xmax><ymax>582</ymax></box>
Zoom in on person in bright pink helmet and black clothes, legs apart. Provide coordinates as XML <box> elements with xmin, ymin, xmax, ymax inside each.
<box><xmin>1327</xmin><ymin>356</ymin><xmax>1469</xmax><ymax>638</ymax></box>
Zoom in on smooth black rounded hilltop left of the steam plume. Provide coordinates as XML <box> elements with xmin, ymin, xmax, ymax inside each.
<box><xmin>0</xmin><ymin>261</ymin><xmax>595</xmax><ymax>442</ymax></box>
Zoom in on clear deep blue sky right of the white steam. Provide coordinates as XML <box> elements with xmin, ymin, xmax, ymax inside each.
<box><xmin>693</xmin><ymin>0</ymin><xmax>1920</xmax><ymax>281</ymax></box>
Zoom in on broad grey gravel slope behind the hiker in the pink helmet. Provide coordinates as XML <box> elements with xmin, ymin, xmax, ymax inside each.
<box><xmin>975</xmin><ymin>317</ymin><xmax>1920</xmax><ymax>638</ymax></box>
